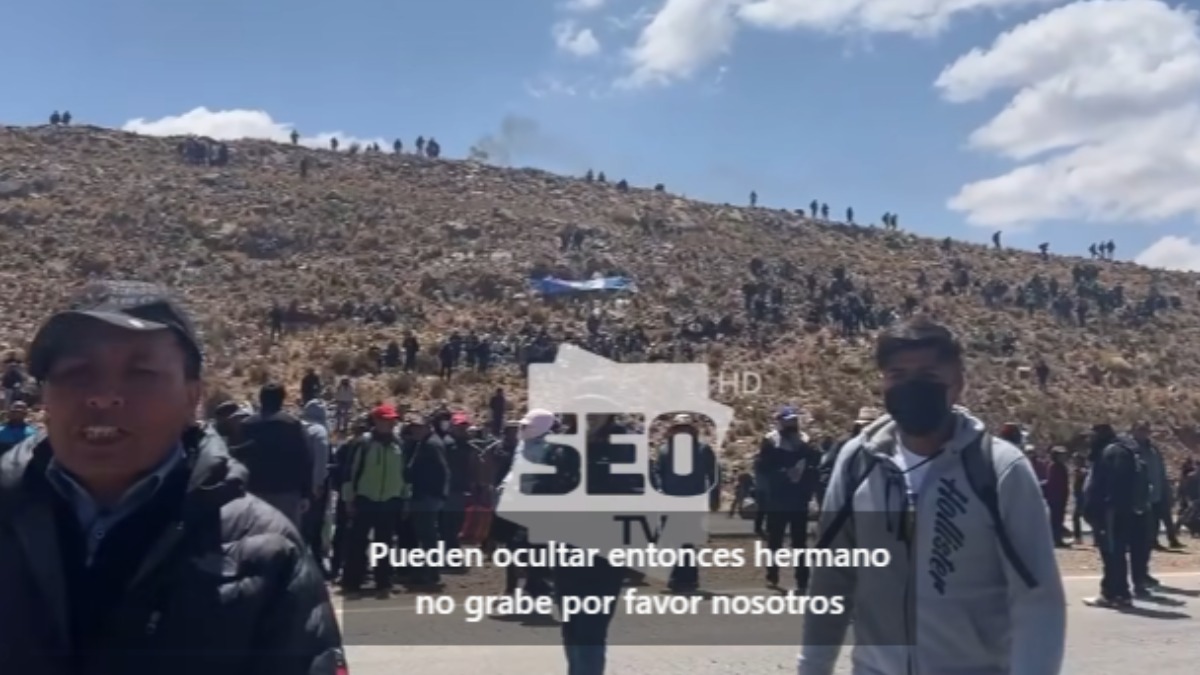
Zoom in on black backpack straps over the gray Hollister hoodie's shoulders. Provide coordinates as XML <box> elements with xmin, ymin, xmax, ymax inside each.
<box><xmin>816</xmin><ymin>432</ymin><xmax>1038</xmax><ymax>589</ymax></box>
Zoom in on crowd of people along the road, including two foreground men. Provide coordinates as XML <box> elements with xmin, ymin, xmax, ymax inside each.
<box><xmin>0</xmin><ymin>281</ymin><xmax>1200</xmax><ymax>675</ymax></box>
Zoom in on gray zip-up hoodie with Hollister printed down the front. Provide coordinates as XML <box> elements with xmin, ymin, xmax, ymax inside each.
<box><xmin>799</xmin><ymin>407</ymin><xmax>1067</xmax><ymax>675</ymax></box>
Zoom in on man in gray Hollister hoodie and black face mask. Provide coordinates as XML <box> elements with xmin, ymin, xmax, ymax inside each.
<box><xmin>799</xmin><ymin>317</ymin><xmax>1067</xmax><ymax>675</ymax></box>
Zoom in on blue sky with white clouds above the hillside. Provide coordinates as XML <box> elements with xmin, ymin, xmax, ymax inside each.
<box><xmin>0</xmin><ymin>0</ymin><xmax>1200</xmax><ymax>270</ymax></box>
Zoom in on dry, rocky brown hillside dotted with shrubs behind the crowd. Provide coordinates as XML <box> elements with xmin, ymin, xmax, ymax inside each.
<box><xmin>0</xmin><ymin>121</ymin><xmax>1200</xmax><ymax>464</ymax></box>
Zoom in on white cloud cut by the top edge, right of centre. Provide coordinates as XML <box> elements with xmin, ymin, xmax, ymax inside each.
<box><xmin>623</xmin><ymin>0</ymin><xmax>1063</xmax><ymax>86</ymax></box>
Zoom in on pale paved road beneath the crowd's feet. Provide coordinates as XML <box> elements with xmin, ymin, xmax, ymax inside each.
<box><xmin>342</xmin><ymin>573</ymin><xmax>1200</xmax><ymax>675</ymax></box>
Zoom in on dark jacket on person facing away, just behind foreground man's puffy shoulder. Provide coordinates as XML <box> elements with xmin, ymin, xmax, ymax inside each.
<box><xmin>232</xmin><ymin>403</ymin><xmax>313</xmax><ymax>497</ymax></box>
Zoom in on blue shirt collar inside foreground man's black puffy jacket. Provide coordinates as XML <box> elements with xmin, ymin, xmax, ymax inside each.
<box><xmin>46</xmin><ymin>446</ymin><xmax>185</xmax><ymax>566</ymax></box>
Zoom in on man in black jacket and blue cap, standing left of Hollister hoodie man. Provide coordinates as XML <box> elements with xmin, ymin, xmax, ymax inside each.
<box><xmin>755</xmin><ymin>406</ymin><xmax>821</xmax><ymax>593</ymax></box>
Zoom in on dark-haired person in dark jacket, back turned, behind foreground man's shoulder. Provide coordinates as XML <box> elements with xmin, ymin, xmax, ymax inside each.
<box><xmin>234</xmin><ymin>384</ymin><xmax>313</xmax><ymax>524</ymax></box>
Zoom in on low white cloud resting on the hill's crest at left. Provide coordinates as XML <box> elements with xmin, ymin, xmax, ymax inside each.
<box><xmin>121</xmin><ymin>107</ymin><xmax>390</xmax><ymax>148</ymax></box>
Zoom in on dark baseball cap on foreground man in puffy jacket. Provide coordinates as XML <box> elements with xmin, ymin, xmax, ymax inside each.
<box><xmin>29</xmin><ymin>281</ymin><xmax>203</xmax><ymax>380</ymax></box>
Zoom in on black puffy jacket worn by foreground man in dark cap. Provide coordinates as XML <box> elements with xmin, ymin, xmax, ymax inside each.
<box><xmin>0</xmin><ymin>428</ymin><xmax>342</xmax><ymax>675</ymax></box>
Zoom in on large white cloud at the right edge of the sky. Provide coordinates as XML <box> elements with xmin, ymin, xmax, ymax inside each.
<box><xmin>936</xmin><ymin>0</ymin><xmax>1200</xmax><ymax>225</ymax></box>
